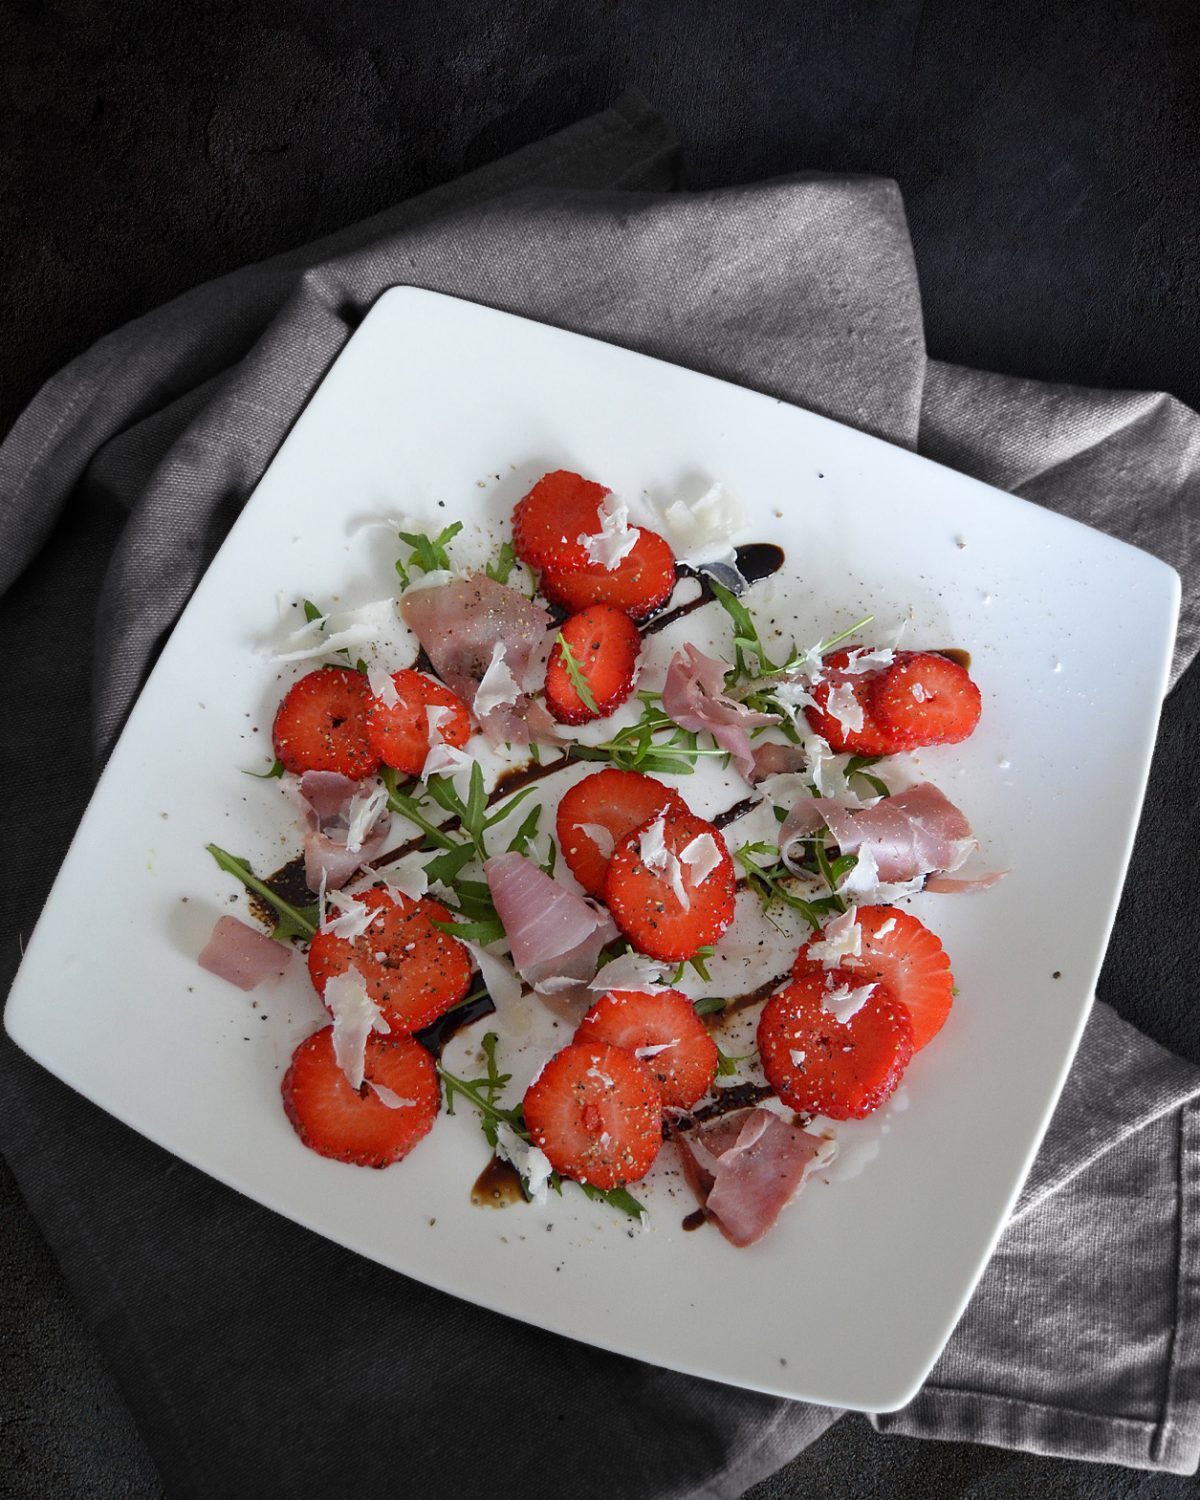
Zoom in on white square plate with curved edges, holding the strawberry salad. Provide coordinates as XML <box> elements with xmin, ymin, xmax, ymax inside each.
<box><xmin>5</xmin><ymin>288</ymin><xmax>1178</xmax><ymax>1410</ymax></box>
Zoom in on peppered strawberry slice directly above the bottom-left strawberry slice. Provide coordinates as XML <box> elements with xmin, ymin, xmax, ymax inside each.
<box><xmin>309</xmin><ymin>890</ymin><xmax>471</xmax><ymax>1035</ymax></box>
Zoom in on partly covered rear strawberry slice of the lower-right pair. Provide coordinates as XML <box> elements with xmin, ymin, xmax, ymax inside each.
<box><xmin>792</xmin><ymin>906</ymin><xmax>954</xmax><ymax>1052</ymax></box>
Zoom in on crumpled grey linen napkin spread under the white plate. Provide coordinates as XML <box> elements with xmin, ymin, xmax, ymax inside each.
<box><xmin>0</xmin><ymin>98</ymin><xmax>1200</xmax><ymax>1497</ymax></box>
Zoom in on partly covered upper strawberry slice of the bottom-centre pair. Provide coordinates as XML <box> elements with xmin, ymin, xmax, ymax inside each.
<box><xmin>575</xmin><ymin>990</ymin><xmax>717</xmax><ymax>1110</ymax></box>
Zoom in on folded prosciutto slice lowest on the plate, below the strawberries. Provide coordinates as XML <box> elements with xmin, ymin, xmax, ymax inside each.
<box><xmin>674</xmin><ymin>1109</ymin><xmax>831</xmax><ymax>1247</ymax></box>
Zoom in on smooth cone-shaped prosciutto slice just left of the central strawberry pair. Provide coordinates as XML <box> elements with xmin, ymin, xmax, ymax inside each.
<box><xmin>483</xmin><ymin>854</ymin><xmax>617</xmax><ymax>990</ymax></box>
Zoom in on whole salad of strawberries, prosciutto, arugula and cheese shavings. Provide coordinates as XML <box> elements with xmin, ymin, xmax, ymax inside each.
<box><xmin>201</xmin><ymin>471</ymin><xmax>998</xmax><ymax>1245</ymax></box>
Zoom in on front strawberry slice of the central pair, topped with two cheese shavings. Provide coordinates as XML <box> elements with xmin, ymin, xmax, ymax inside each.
<box><xmin>605</xmin><ymin>810</ymin><xmax>737</xmax><ymax>963</ymax></box>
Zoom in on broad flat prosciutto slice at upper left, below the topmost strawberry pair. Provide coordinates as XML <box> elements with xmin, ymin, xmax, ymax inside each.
<box><xmin>401</xmin><ymin>573</ymin><xmax>551</xmax><ymax>744</ymax></box>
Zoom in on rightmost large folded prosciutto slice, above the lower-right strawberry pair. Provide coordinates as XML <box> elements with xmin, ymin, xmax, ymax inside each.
<box><xmin>779</xmin><ymin>782</ymin><xmax>977</xmax><ymax>882</ymax></box>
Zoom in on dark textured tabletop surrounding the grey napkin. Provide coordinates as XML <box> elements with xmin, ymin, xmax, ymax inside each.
<box><xmin>0</xmin><ymin>0</ymin><xmax>1200</xmax><ymax>1500</ymax></box>
